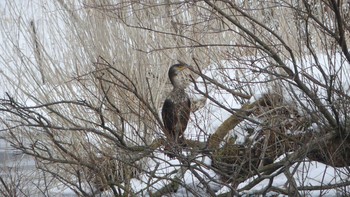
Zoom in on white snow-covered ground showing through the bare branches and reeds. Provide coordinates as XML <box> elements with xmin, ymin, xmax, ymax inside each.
<box><xmin>0</xmin><ymin>2</ymin><xmax>350</xmax><ymax>196</ymax></box>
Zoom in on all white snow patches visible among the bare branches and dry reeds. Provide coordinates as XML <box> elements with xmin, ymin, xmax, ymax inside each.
<box><xmin>0</xmin><ymin>0</ymin><xmax>350</xmax><ymax>196</ymax></box>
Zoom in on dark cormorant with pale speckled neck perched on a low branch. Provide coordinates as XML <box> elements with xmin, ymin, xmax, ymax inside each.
<box><xmin>162</xmin><ymin>63</ymin><xmax>191</xmax><ymax>158</ymax></box>
